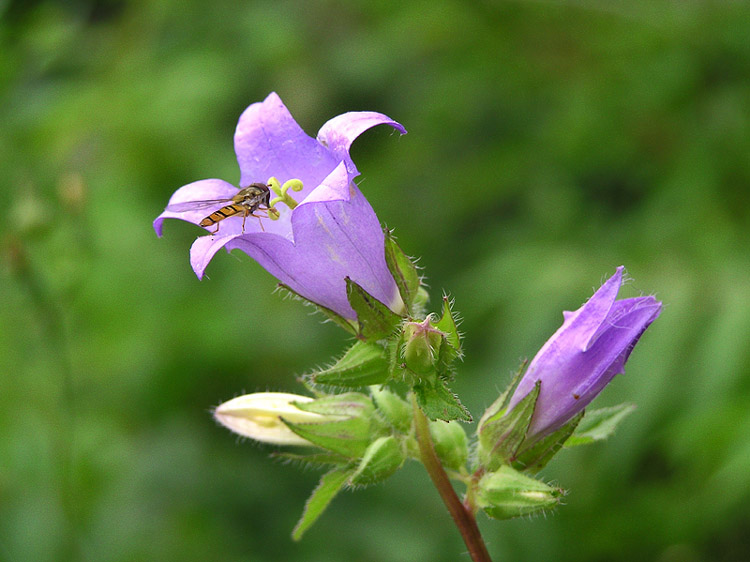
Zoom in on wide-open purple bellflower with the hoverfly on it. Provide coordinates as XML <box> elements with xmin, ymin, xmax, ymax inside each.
<box><xmin>154</xmin><ymin>93</ymin><xmax>406</xmax><ymax>320</ymax></box>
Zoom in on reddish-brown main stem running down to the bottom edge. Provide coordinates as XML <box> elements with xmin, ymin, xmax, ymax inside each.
<box><xmin>411</xmin><ymin>394</ymin><xmax>492</xmax><ymax>562</ymax></box>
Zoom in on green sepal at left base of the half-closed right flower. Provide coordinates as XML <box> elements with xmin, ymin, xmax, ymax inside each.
<box><xmin>477</xmin><ymin>382</ymin><xmax>541</xmax><ymax>471</ymax></box>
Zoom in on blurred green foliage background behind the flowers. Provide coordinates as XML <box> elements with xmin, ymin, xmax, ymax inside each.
<box><xmin>0</xmin><ymin>0</ymin><xmax>750</xmax><ymax>562</ymax></box>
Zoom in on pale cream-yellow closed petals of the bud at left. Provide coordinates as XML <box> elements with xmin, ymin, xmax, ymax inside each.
<box><xmin>214</xmin><ymin>392</ymin><xmax>327</xmax><ymax>445</ymax></box>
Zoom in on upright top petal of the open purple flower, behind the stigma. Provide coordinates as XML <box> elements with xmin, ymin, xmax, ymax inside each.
<box><xmin>234</xmin><ymin>93</ymin><xmax>339</xmax><ymax>192</ymax></box>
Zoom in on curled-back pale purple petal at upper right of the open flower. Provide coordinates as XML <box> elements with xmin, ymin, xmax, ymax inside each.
<box><xmin>318</xmin><ymin>111</ymin><xmax>406</xmax><ymax>177</ymax></box>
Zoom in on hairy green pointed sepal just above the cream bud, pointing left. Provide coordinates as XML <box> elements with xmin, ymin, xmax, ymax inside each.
<box><xmin>309</xmin><ymin>341</ymin><xmax>390</xmax><ymax>388</ymax></box>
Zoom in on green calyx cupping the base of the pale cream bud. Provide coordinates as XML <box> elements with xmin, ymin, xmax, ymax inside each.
<box><xmin>282</xmin><ymin>392</ymin><xmax>382</xmax><ymax>458</ymax></box>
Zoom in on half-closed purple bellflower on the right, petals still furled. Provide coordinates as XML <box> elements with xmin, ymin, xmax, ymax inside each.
<box><xmin>508</xmin><ymin>266</ymin><xmax>661</xmax><ymax>441</ymax></box>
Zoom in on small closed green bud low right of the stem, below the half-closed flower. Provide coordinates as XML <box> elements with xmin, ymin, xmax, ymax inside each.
<box><xmin>476</xmin><ymin>465</ymin><xmax>564</xmax><ymax>519</ymax></box>
